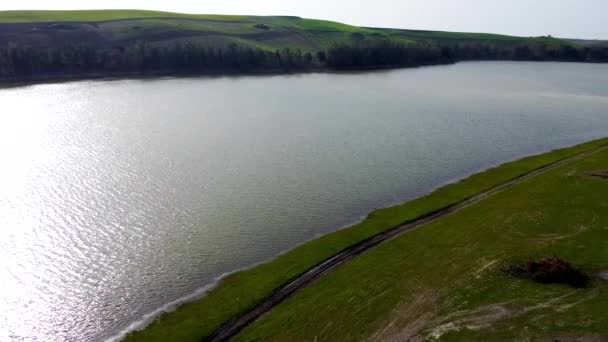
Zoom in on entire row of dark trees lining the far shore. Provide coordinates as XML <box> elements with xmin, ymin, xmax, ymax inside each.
<box><xmin>0</xmin><ymin>40</ymin><xmax>608</xmax><ymax>80</ymax></box>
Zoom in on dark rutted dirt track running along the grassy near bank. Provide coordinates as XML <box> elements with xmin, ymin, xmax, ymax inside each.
<box><xmin>204</xmin><ymin>146</ymin><xmax>608</xmax><ymax>342</ymax></box>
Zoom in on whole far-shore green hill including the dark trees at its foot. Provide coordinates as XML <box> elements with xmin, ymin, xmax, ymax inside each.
<box><xmin>0</xmin><ymin>10</ymin><xmax>608</xmax><ymax>82</ymax></box>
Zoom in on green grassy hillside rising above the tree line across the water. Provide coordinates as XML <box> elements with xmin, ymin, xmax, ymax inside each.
<box><xmin>0</xmin><ymin>10</ymin><xmax>574</xmax><ymax>51</ymax></box>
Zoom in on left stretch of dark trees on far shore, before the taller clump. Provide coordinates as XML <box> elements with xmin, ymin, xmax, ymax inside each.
<box><xmin>0</xmin><ymin>42</ymin><xmax>318</xmax><ymax>79</ymax></box>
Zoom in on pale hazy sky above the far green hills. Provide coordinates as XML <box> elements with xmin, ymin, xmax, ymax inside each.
<box><xmin>0</xmin><ymin>0</ymin><xmax>608</xmax><ymax>39</ymax></box>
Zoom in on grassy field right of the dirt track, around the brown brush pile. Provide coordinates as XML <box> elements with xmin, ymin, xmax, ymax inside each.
<box><xmin>236</xmin><ymin>143</ymin><xmax>608</xmax><ymax>341</ymax></box>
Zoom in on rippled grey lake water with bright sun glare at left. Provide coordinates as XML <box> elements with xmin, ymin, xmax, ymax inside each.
<box><xmin>0</xmin><ymin>62</ymin><xmax>608</xmax><ymax>341</ymax></box>
